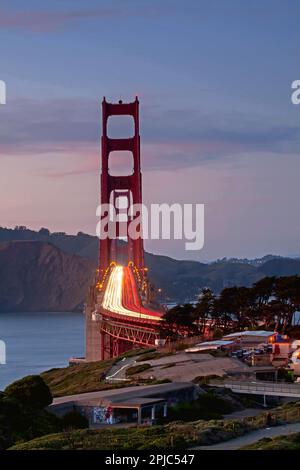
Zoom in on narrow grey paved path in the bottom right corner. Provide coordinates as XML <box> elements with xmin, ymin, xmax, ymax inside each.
<box><xmin>193</xmin><ymin>423</ymin><xmax>300</xmax><ymax>450</ymax></box>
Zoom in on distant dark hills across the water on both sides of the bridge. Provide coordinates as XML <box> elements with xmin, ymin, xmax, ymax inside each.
<box><xmin>0</xmin><ymin>227</ymin><xmax>300</xmax><ymax>311</ymax></box>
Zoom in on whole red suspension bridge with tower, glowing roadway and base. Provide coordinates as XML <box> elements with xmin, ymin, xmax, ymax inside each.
<box><xmin>85</xmin><ymin>97</ymin><xmax>164</xmax><ymax>362</ymax></box>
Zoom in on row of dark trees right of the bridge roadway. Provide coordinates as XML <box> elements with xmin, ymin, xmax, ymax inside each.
<box><xmin>163</xmin><ymin>275</ymin><xmax>300</xmax><ymax>337</ymax></box>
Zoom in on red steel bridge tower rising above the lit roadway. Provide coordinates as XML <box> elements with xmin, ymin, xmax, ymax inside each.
<box><xmin>99</xmin><ymin>96</ymin><xmax>144</xmax><ymax>272</ymax></box>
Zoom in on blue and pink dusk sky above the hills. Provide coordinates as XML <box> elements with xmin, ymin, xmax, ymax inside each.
<box><xmin>0</xmin><ymin>0</ymin><xmax>300</xmax><ymax>261</ymax></box>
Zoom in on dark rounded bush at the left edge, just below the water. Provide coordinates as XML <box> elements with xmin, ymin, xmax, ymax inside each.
<box><xmin>4</xmin><ymin>375</ymin><xmax>52</xmax><ymax>409</ymax></box>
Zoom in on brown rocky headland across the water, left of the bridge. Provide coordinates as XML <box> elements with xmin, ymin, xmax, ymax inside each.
<box><xmin>0</xmin><ymin>241</ymin><xmax>96</xmax><ymax>312</ymax></box>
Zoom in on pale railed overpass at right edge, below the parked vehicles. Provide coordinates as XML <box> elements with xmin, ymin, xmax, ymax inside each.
<box><xmin>209</xmin><ymin>380</ymin><xmax>300</xmax><ymax>399</ymax></box>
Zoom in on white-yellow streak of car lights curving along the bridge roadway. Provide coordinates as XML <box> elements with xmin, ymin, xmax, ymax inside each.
<box><xmin>102</xmin><ymin>266</ymin><xmax>161</xmax><ymax>321</ymax></box>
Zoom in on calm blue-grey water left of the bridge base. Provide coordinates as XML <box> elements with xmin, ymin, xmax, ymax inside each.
<box><xmin>0</xmin><ymin>312</ymin><xmax>85</xmax><ymax>390</ymax></box>
